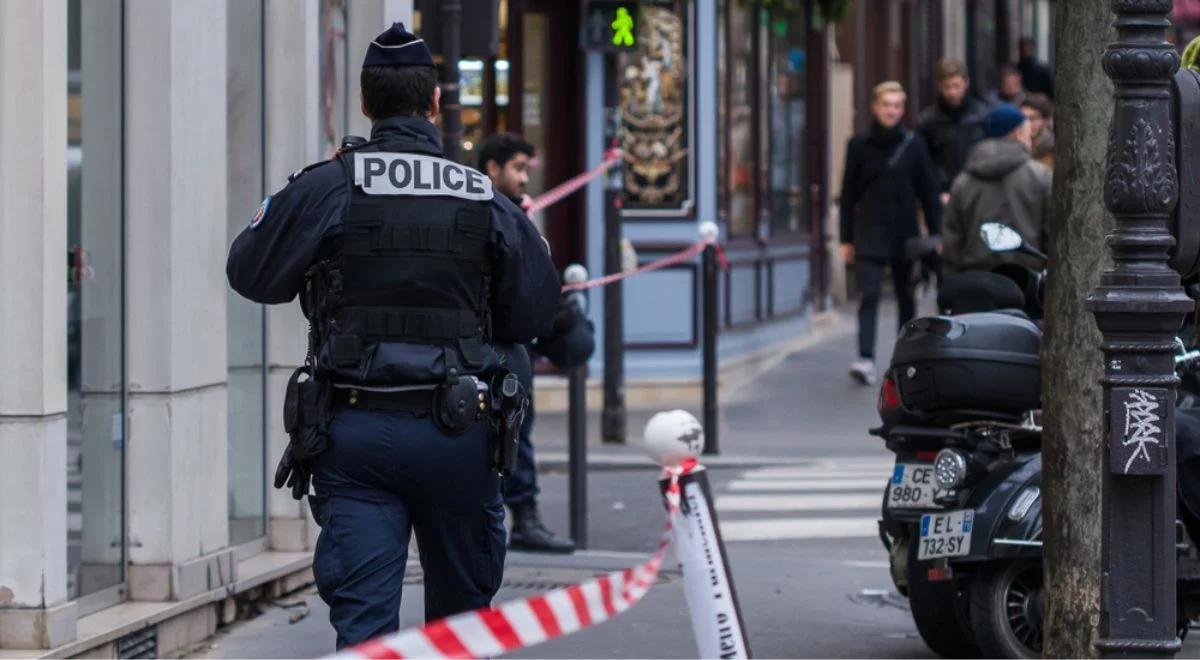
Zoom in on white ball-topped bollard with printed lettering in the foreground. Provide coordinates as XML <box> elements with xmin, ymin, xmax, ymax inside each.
<box><xmin>642</xmin><ymin>410</ymin><xmax>750</xmax><ymax>658</ymax></box>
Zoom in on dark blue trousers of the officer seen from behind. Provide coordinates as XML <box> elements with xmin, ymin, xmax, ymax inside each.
<box><xmin>310</xmin><ymin>409</ymin><xmax>505</xmax><ymax>649</ymax></box>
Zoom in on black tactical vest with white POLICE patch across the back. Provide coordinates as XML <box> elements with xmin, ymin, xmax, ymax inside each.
<box><xmin>316</xmin><ymin>139</ymin><xmax>494</xmax><ymax>386</ymax></box>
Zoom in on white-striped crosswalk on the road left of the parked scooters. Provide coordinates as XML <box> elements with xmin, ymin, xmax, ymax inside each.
<box><xmin>714</xmin><ymin>458</ymin><xmax>893</xmax><ymax>541</ymax></box>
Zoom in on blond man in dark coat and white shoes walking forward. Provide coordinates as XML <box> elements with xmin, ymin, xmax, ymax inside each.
<box><xmin>840</xmin><ymin>82</ymin><xmax>942</xmax><ymax>385</ymax></box>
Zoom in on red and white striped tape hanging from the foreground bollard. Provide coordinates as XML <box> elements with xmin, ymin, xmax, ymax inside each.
<box><xmin>337</xmin><ymin>458</ymin><xmax>696</xmax><ymax>659</ymax></box>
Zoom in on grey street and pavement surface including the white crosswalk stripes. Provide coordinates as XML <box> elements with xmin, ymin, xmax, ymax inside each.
<box><xmin>189</xmin><ymin>303</ymin><xmax>932</xmax><ymax>658</ymax></box>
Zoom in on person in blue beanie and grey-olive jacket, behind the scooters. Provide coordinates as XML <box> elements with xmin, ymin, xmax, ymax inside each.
<box><xmin>942</xmin><ymin>103</ymin><xmax>1052</xmax><ymax>275</ymax></box>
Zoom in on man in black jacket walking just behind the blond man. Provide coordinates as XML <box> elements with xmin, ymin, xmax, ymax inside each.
<box><xmin>917</xmin><ymin>60</ymin><xmax>988</xmax><ymax>198</ymax></box>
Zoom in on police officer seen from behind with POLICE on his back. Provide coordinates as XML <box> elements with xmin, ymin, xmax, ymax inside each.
<box><xmin>227</xmin><ymin>23</ymin><xmax>560</xmax><ymax>648</ymax></box>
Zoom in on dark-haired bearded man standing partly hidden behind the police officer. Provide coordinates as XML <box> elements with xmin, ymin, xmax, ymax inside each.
<box><xmin>479</xmin><ymin>133</ymin><xmax>595</xmax><ymax>553</ymax></box>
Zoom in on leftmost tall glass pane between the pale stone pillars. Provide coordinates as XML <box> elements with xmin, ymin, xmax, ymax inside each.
<box><xmin>64</xmin><ymin>0</ymin><xmax>126</xmax><ymax>611</ymax></box>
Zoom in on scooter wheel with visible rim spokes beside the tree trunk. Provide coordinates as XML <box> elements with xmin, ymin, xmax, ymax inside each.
<box><xmin>971</xmin><ymin>559</ymin><xmax>1045</xmax><ymax>658</ymax></box>
